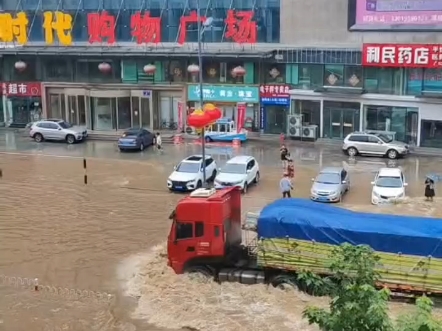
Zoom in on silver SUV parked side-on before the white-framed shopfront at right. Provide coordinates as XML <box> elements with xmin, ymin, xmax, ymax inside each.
<box><xmin>342</xmin><ymin>132</ymin><xmax>410</xmax><ymax>159</ymax></box>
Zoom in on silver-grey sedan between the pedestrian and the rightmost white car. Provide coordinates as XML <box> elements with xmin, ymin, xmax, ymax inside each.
<box><xmin>310</xmin><ymin>167</ymin><xmax>350</xmax><ymax>202</ymax></box>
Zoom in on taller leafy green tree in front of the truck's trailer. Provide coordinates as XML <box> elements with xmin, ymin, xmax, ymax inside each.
<box><xmin>303</xmin><ymin>244</ymin><xmax>394</xmax><ymax>331</ymax></box>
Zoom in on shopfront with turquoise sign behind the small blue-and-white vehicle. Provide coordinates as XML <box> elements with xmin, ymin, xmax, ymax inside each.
<box><xmin>187</xmin><ymin>84</ymin><xmax>260</xmax><ymax>131</ymax></box>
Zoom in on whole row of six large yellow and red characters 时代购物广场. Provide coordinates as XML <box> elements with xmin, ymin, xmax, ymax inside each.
<box><xmin>0</xmin><ymin>10</ymin><xmax>257</xmax><ymax>46</ymax></box>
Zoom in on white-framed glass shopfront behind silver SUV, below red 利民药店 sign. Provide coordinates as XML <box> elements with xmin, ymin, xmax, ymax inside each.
<box><xmin>290</xmin><ymin>90</ymin><xmax>422</xmax><ymax>146</ymax></box>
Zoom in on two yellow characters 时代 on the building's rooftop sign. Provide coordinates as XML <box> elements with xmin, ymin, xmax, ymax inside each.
<box><xmin>0</xmin><ymin>11</ymin><xmax>72</xmax><ymax>46</ymax></box>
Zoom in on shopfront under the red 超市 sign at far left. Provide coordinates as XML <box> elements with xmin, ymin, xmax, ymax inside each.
<box><xmin>2</xmin><ymin>82</ymin><xmax>42</xmax><ymax>128</ymax></box>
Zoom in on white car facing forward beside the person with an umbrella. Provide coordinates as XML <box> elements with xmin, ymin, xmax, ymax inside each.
<box><xmin>371</xmin><ymin>168</ymin><xmax>408</xmax><ymax>205</ymax></box>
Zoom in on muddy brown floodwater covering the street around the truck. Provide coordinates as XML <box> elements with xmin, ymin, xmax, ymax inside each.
<box><xmin>0</xmin><ymin>155</ymin><xmax>442</xmax><ymax>331</ymax></box>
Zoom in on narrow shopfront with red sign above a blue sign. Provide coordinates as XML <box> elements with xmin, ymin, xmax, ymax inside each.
<box><xmin>259</xmin><ymin>84</ymin><xmax>290</xmax><ymax>134</ymax></box>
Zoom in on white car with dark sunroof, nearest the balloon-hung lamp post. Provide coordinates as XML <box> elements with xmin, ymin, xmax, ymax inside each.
<box><xmin>167</xmin><ymin>155</ymin><xmax>217</xmax><ymax>191</ymax></box>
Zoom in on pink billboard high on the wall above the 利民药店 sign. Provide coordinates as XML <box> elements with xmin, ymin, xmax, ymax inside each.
<box><xmin>350</xmin><ymin>0</ymin><xmax>442</xmax><ymax>30</ymax></box>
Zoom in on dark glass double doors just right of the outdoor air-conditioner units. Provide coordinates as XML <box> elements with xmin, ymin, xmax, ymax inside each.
<box><xmin>323</xmin><ymin>101</ymin><xmax>361</xmax><ymax>139</ymax></box>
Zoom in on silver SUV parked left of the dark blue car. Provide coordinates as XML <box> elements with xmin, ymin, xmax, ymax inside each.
<box><xmin>29</xmin><ymin>119</ymin><xmax>87</xmax><ymax>144</ymax></box>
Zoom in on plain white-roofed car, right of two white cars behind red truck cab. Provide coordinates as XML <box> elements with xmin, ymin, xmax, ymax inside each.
<box><xmin>215</xmin><ymin>155</ymin><xmax>260</xmax><ymax>193</ymax></box>
